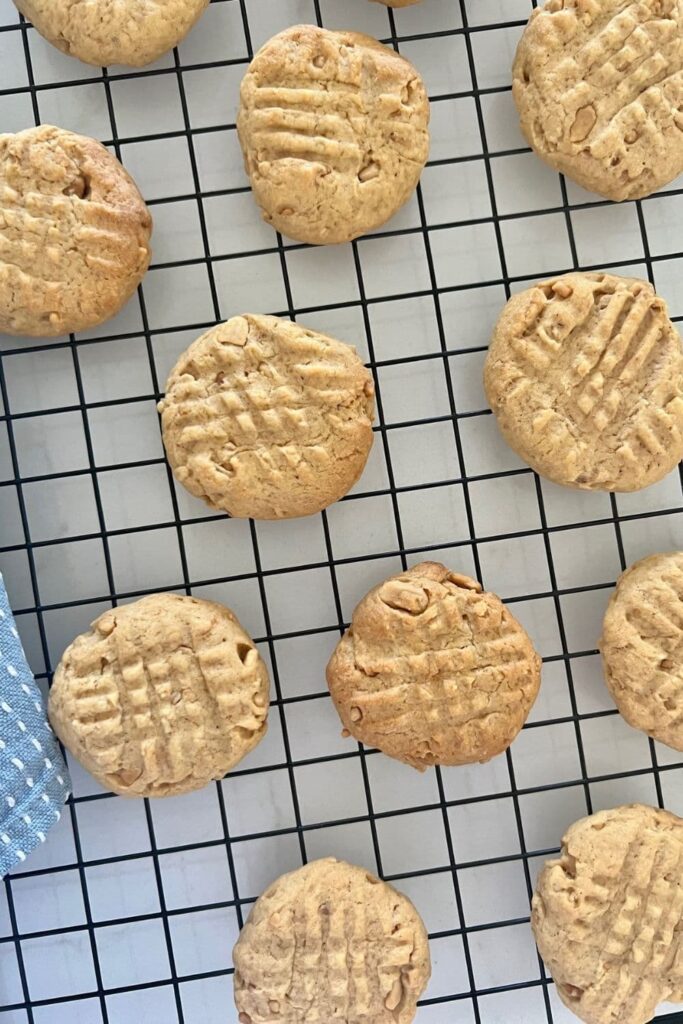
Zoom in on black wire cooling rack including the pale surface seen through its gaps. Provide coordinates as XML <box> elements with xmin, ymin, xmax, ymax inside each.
<box><xmin>0</xmin><ymin>0</ymin><xmax>683</xmax><ymax>1024</ymax></box>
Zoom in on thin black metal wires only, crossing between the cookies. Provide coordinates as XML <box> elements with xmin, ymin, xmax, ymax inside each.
<box><xmin>0</xmin><ymin>0</ymin><xmax>683</xmax><ymax>1024</ymax></box>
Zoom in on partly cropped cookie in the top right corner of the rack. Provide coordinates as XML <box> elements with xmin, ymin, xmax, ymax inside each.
<box><xmin>512</xmin><ymin>0</ymin><xmax>683</xmax><ymax>200</ymax></box>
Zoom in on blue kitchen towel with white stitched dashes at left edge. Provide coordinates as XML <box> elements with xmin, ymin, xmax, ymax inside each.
<box><xmin>0</xmin><ymin>574</ymin><xmax>71</xmax><ymax>878</ymax></box>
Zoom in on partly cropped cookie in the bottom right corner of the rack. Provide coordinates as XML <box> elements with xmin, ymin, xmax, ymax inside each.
<box><xmin>531</xmin><ymin>804</ymin><xmax>683</xmax><ymax>1024</ymax></box>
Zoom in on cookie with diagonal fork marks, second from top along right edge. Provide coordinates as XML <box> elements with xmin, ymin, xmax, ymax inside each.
<box><xmin>484</xmin><ymin>273</ymin><xmax>683</xmax><ymax>490</ymax></box>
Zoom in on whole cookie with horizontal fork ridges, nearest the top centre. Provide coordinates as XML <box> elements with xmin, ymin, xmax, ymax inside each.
<box><xmin>238</xmin><ymin>25</ymin><xmax>429</xmax><ymax>245</ymax></box>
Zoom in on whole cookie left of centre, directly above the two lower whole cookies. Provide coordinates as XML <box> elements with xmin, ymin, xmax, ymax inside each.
<box><xmin>159</xmin><ymin>314</ymin><xmax>375</xmax><ymax>519</ymax></box>
